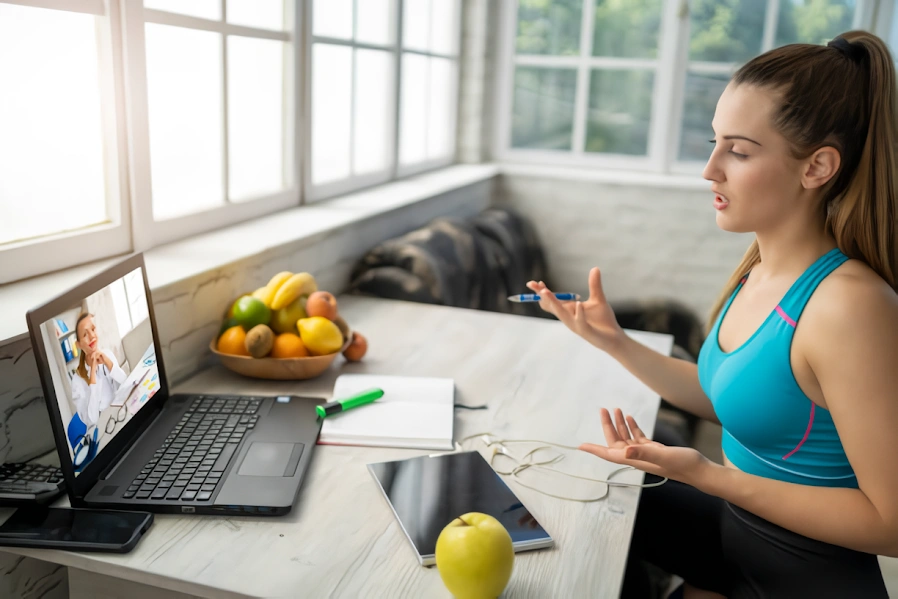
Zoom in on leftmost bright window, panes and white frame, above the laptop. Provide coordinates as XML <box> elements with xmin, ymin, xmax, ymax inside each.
<box><xmin>0</xmin><ymin>0</ymin><xmax>131</xmax><ymax>283</ymax></box>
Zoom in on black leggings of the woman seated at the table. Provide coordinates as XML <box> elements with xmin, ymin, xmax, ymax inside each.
<box><xmin>621</xmin><ymin>476</ymin><xmax>888</xmax><ymax>599</ymax></box>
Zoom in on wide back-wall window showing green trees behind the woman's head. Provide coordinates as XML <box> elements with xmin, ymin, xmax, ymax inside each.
<box><xmin>497</xmin><ymin>0</ymin><xmax>891</xmax><ymax>172</ymax></box>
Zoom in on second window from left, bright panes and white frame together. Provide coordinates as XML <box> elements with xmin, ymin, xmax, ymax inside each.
<box><xmin>122</xmin><ymin>0</ymin><xmax>299</xmax><ymax>249</ymax></box>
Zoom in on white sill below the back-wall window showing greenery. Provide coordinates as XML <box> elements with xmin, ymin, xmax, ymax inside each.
<box><xmin>499</xmin><ymin>163</ymin><xmax>711</xmax><ymax>191</ymax></box>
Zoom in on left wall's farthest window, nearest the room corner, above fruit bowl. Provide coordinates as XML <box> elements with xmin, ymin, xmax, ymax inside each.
<box><xmin>308</xmin><ymin>0</ymin><xmax>461</xmax><ymax>199</ymax></box>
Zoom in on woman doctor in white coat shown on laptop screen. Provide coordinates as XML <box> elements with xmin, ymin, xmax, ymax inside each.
<box><xmin>72</xmin><ymin>312</ymin><xmax>127</xmax><ymax>426</ymax></box>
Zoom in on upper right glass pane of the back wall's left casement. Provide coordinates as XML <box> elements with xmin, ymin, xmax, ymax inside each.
<box><xmin>592</xmin><ymin>0</ymin><xmax>662</xmax><ymax>58</ymax></box>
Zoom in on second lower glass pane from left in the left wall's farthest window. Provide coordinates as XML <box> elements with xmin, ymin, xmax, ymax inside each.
<box><xmin>352</xmin><ymin>50</ymin><xmax>396</xmax><ymax>174</ymax></box>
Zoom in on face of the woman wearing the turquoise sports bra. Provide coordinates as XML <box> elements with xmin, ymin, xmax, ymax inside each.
<box><xmin>702</xmin><ymin>83</ymin><xmax>803</xmax><ymax>233</ymax></box>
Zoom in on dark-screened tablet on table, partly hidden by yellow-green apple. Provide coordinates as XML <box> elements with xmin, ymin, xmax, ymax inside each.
<box><xmin>368</xmin><ymin>451</ymin><xmax>553</xmax><ymax>566</ymax></box>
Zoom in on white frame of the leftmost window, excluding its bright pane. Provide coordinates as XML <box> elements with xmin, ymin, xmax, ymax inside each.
<box><xmin>0</xmin><ymin>0</ymin><xmax>132</xmax><ymax>285</ymax></box>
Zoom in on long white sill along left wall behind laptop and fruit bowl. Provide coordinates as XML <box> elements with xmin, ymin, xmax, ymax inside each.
<box><xmin>0</xmin><ymin>164</ymin><xmax>499</xmax><ymax>344</ymax></box>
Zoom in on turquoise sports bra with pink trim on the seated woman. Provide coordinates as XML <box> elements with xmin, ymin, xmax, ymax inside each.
<box><xmin>698</xmin><ymin>248</ymin><xmax>858</xmax><ymax>488</ymax></box>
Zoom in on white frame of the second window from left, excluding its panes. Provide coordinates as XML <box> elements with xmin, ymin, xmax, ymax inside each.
<box><xmin>120</xmin><ymin>0</ymin><xmax>303</xmax><ymax>252</ymax></box>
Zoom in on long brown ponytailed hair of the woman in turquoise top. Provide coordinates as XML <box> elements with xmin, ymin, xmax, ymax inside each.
<box><xmin>709</xmin><ymin>31</ymin><xmax>898</xmax><ymax>327</ymax></box>
